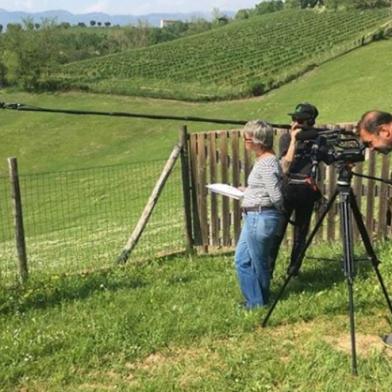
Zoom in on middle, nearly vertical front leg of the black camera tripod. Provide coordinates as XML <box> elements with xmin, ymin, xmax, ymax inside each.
<box><xmin>339</xmin><ymin>190</ymin><xmax>358</xmax><ymax>375</ymax></box>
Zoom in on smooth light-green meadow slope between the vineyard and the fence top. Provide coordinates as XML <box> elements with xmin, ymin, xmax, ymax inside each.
<box><xmin>0</xmin><ymin>40</ymin><xmax>392</xmax><ymax>173</ymax></box>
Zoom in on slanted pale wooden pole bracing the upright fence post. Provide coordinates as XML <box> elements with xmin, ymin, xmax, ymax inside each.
<box><xmin>117</xmin><ymin>144</ymin><xmax>182</xmax><ymax>264</ymax></box>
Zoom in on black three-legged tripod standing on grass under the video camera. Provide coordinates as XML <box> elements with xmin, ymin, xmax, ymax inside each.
<box><xmin>262</xmin><ymin>164</ymin><xmax>392</xmax><ymax>375</ymax></box>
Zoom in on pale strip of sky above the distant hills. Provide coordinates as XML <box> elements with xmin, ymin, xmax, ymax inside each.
<box><xmin>0</xmin><ymin>0</ymin><xmax>261</xmax><ymax>15</ymax></box>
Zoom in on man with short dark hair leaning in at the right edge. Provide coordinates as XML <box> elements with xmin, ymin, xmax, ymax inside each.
<box><xmin>357</xmin><ymin>110</ymin><xmax>392</xmax><ymax>347</ymax></box>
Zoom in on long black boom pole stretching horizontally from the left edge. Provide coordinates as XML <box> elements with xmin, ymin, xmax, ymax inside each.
<box><xmin>0</xmin><ymin>102</ymin><xmax>290</xmax><ymax>129</ymax></box>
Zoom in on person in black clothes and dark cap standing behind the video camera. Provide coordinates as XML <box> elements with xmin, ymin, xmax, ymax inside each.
<box><xmin>270</xmin><ymin>103</ymin><xmax>321</xmax><ymax>275</ymax></box>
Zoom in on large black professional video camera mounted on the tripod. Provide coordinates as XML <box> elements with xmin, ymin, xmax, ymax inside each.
<box><xmin>297</xmin><ymin>127</ymin><xmax>366</xmax><ymax>165</ymax></box>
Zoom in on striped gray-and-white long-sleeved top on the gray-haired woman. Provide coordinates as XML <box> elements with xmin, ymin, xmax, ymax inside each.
<box><xmin>241</xmin><ymin>155</ymin><xmax>283</xmax><ymax>210</ymax></box>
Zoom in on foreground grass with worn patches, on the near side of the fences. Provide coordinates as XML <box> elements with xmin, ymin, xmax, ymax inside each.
<box><xmin>0</xmin><ymin>246</ymin><xmax>392</xmax><ymax>391</ymax></box>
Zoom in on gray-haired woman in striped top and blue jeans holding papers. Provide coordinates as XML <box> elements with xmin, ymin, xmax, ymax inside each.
<box><xmin>235</xmin><ymin>120</ymin><xmax>283</xmax><ymax>309</ymax></box>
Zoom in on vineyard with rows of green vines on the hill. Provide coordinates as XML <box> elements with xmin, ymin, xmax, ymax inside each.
<box><xmin>49</xmin><ymin>9</ymin><xmax>391</xmax><ymax>100</ymax></box>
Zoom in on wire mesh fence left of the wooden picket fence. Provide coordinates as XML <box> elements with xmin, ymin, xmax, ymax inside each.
<box><xmin>0</xmin><ymin>161</ymin><xmax>185</xmax><ymax>283</ymax></box>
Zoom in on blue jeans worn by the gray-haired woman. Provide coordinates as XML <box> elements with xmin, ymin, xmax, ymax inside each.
<box><xmin>235</xmin><ymin>209</ymin><xmax>282</xmax><ymax>309</ymax></box>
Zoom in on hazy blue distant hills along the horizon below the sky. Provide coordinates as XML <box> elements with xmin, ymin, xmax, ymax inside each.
<box><xmin>0</xmin><ymin>9</ymin><xmax>234</xmax><ymax>26</ymax></box>
